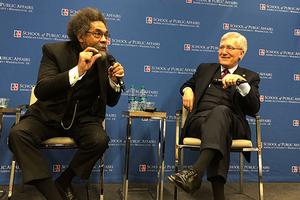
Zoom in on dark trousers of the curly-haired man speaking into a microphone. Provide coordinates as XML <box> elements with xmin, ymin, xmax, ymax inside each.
<box><xmin>9</xmin><ymin>116</ymin><xmax>109</xmax><ymax>183</ymax></box>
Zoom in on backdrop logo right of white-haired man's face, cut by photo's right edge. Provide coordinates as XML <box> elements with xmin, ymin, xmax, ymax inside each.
<box><xmin>258</xmin><ymin>49</ymin><xmax>300</xmax><ymax>58</ymax></box>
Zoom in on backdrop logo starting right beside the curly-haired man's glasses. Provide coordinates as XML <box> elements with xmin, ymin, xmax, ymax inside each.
<box><xmin>108</xmin><ymin>38</ymin><xmax>160</xmax><ymax>49</ymax></box>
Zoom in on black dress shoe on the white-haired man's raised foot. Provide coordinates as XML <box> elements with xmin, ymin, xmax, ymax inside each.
<box><xmin>168</xmin><ymin>169</ymin><xmax>202</xmax><ymax>193</ymax></box>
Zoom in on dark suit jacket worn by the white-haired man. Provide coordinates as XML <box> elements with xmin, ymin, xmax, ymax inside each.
<box><xmin>180</xmin><ymin>63</ymin><xmax>260</xmax><ymax>142</ymax></box>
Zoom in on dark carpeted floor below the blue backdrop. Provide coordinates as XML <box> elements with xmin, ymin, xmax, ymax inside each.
<box><xmin>1</xmin><ymin>182</ymin><xmax>300</xmax><ymax>200</ymax></box>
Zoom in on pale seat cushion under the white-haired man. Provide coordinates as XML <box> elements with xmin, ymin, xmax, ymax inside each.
<box><xmin>183</xmin><ymin>137</ymin><xmax>252</xmax><ymax>149</ymax></box>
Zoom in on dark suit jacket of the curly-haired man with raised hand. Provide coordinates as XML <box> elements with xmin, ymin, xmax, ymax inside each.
<box><xmin>25</xmin><ymin>41</ymin><xmax>120</xmax><ymax>125</ymax></box>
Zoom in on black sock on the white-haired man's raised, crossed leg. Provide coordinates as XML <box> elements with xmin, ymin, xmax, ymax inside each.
<box><xmin>193</xmin><ymin>149</ymin><xmax>218</xmax><ymax>175</ymax></box>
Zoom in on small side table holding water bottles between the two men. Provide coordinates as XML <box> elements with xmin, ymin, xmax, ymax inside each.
<box><xmin>122</xmin><ymin>111</ymin><xmax>167</xmax><ymax>200</ymax></box>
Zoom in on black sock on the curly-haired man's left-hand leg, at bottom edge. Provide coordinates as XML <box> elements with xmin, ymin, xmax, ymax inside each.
<box><xmin>30</xmin><ymin>178</ymin><xmax>63</xmax><ymax>200</ymax></box>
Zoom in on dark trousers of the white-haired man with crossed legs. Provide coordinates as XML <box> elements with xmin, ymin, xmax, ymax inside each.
<box><xmin>186</xmin><ymin>105</ymin><xmax>243</xmax><ymax>181</ymax></box>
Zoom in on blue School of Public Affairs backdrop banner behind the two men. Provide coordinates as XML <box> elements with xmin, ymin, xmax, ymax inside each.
<box><xmin>0</xmin><ymin>0</ymin><xmax>300</xmax><ymax>184</ymax></box>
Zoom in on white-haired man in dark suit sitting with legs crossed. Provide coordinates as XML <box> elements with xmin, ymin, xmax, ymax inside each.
<box><xmin>168</xmin><ymin>32</ymin><xmax>260</xmax><ymax>200</ymax></box>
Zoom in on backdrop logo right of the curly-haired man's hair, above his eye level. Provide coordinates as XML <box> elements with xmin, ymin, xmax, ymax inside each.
<box><xmin>146</xmin><ymin>16</ymin><xmax>200</xmax><ymax>28</ymax></box>
